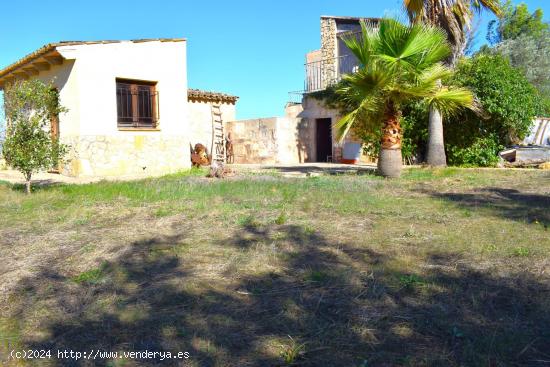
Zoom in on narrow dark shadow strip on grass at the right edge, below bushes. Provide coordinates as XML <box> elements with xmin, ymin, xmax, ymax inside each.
<box><xmin>422</xmin><ymin>187</ymin><xmax>550</xmax><ymax>227</ymax></box>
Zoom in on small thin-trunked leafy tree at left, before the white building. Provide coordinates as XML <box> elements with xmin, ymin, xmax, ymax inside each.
<box><xmin>2</xmin><ymin>80</ymin><xmax>67</xmax><ymax>194</ymax></box>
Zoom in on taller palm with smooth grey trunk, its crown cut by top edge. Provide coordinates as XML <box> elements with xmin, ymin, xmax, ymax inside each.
<box><xmin>403</xmin><ymin>0</ymin><xmax>502</xmax><ymax>166</ymax></box>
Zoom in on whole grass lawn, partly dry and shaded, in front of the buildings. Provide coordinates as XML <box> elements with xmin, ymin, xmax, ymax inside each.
<box><xmin>0</xmin><ymin>169</ymin><xmax>550</xmax><ymax>367</ymax></box>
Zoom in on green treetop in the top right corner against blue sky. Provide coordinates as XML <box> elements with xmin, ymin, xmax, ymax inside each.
<box><xmin>487</xmin><ymin>0</ymin><xmax>550</xmax><ymax>45</ymax></box>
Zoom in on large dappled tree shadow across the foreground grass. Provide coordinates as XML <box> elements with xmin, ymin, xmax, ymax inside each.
<box><xmin>7</xmin><ymin>223</ymin><xmax>550</xmax><ymax>366</ymax></box>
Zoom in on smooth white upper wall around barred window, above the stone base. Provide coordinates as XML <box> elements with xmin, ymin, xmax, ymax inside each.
<box><xmin>56</xmin><ymin>41</ymin><xmax>188</xmax><ymax>136</ymax></box>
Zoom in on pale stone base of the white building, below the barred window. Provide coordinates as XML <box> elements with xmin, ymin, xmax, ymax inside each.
<box><xmin>62</xmin><ymin>133</ymin><xmax>191</xmax><ymax>176</ymax></box>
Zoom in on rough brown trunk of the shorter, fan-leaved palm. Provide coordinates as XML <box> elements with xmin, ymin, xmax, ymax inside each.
<box><xmin>378</xmin><ymin>108</ymin><xmax>403</xmax><ymax>178</ymax></box>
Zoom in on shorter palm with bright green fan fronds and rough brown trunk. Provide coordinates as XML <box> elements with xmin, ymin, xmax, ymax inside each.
<box><xmin>336</xmin><ymin>19</ymin><xmax>476</xmax><ymax>177</ymax></box>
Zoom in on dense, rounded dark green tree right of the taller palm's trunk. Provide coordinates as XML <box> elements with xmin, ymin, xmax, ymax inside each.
<box><xmin>445</xmin><ymin>53</ymin><xmax>541</xmax><ymax>165</ymax></box>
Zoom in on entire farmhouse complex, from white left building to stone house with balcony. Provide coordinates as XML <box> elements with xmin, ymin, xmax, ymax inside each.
<box><xmin>0</xmin><ymin>16</ymin><xmax>378</xmax><ymax>176</ymax></box>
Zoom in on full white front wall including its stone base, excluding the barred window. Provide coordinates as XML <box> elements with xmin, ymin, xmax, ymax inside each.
<box><xmin>50</xmin><ymin>41</ymin><xmax>190</xmax><ymax>176</ymax></box>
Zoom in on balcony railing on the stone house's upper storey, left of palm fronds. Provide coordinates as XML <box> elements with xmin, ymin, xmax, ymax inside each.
<box><xmin>304</xmin><ymin>55</ymin><xmax>359</xmax><ymax>93</ymax></box>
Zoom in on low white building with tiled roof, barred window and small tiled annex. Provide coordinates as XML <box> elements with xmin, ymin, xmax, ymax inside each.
<box><xmin>0</xmin><ymin>39</ymin><xmax>237</xmax><ymax>176</ymax></box>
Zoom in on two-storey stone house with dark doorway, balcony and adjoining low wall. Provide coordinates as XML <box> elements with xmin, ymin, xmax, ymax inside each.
<box><xmin>228</xmin><ymin>16</ymin><xmax>379</xmax><ymax>164</ymax></box>
